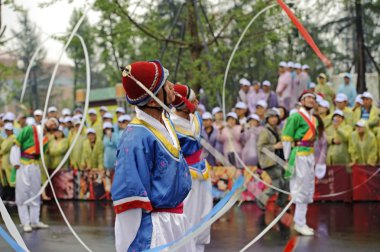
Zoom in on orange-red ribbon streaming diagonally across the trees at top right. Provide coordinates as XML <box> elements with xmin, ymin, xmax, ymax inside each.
<box><xmin>277</xmin><ymin>0</ymin><xmax>332</xmax><ymax>68</ymax></box>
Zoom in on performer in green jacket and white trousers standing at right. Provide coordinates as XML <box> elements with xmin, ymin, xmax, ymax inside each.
<box><xmin>282</xmin><ymin>90</ymin><xmax>317</xmax><ymax>235</ymax></box>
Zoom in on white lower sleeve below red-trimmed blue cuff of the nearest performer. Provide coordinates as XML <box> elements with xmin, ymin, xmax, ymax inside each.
<box><xmin>115</xmin><ymin>208</ymin><xmax>142</xmax><ymax>252</ymax></box>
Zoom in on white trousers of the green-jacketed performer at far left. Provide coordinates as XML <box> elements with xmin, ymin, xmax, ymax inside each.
<box><xmin>16</xmin><ymin>164</ymin><xmax>41</xmax><ymax>225</ymax></box>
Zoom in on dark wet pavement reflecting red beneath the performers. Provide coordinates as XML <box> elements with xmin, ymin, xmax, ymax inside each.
<box><xmin>0</xmin><ymin>201</ymin><xmax>380</xmax><ymax>252</ymax></box>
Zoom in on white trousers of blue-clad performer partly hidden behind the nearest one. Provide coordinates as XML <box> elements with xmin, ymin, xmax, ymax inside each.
<box><xmin>184</xmin><ymin>179</ymin><xmax>213</xmax><ymax>252</ymax></box>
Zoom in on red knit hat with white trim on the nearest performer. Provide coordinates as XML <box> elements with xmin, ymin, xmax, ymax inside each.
<box><xmin>122</xmin><ymin>60</ymin><xmax>169</xmax><ymax>106</ymax></box>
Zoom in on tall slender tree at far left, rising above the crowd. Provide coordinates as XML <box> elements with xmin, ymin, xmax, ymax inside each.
<box><xmin>12</xmin><ymin>11</ymin><xmax>46</xmax><ymax>109</ymax></box>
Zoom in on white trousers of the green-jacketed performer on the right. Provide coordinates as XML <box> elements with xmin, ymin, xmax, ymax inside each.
<box><xmin>290</xmin><ymin>154</ymin><xmax>315</xmax><ymax>227</ymax></box>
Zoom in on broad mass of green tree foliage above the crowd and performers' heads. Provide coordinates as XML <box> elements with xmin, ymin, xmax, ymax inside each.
<box><xmin>35</xmin><ymin>0</ymin><xmax>380</xmax><ymax>107</ymax></box>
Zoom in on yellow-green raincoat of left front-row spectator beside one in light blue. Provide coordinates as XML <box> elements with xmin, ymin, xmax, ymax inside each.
<box><xmin>81</xmin><ymin>138</ymin><xmax>104</xmax><ymax>169</ymax></box>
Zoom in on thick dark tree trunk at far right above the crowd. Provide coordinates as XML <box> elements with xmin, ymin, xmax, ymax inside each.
<box><xmin>355</xmin><ymin>0</ymin><xmax>367</xmax><ymax>93</ymax></box>
